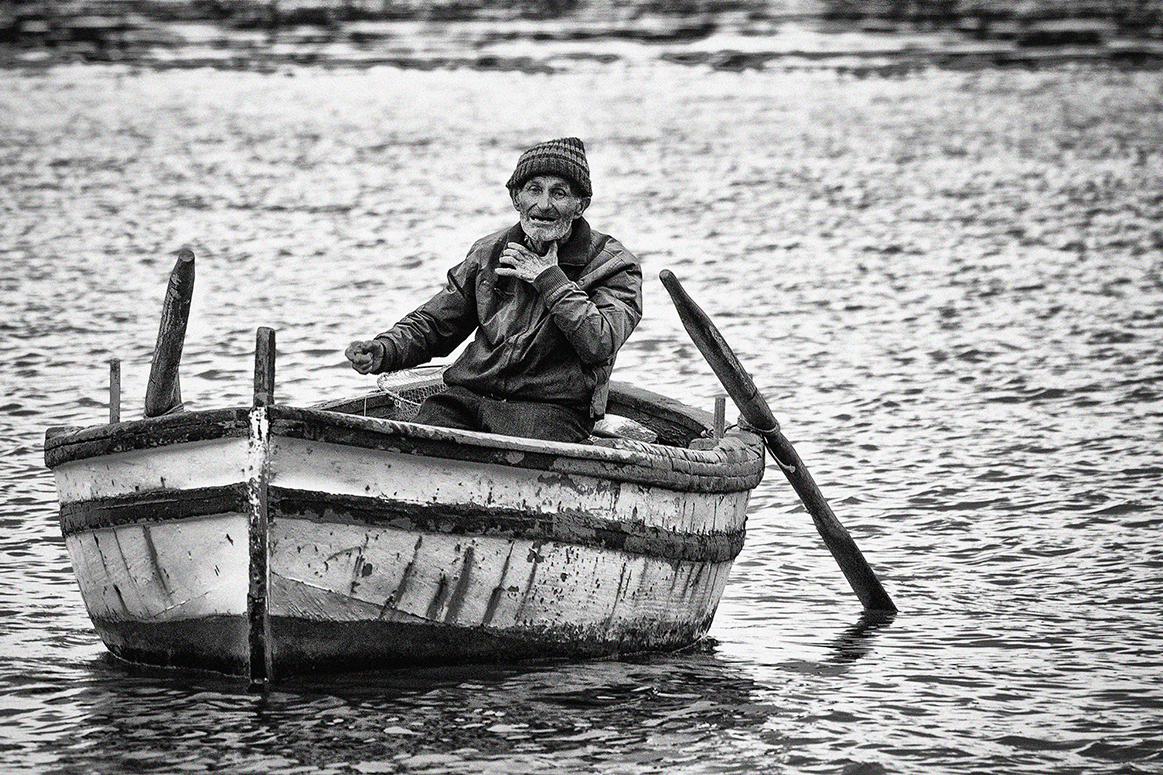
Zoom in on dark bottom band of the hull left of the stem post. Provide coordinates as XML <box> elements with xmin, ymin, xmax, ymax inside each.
<box><xmin>93</xmin><ymin>616</ymin><xmax>249</xmax><ymax>675</ymax></box>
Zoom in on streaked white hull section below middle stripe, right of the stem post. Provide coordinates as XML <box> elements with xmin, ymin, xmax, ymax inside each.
<box><xmin>271</xmin><ymin>518</ymin><xmax>729</xmax><ymax>640</ymax></box>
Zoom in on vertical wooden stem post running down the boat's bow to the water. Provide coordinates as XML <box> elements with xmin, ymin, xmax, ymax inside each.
<box><xmin>247</xmin><ymin>327</ymin><xmax>274</xmax><ymax>691</ymax></box>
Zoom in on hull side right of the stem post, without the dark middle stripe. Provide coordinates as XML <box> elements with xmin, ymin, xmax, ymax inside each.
<box><xmin>262</xmin><ymin>430</ymin><xmax>747</xmax><ymax>663</ymax></box>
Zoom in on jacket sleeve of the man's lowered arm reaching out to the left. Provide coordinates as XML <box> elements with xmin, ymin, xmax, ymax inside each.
<box><xmin>376</xmin><ymin>258</ymin><xmax>477</xmax><ymax>372</ymax></box>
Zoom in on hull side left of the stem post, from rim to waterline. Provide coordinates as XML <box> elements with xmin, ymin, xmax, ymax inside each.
<box><xmin>53</xmin><ymin>430</ymin><xmax>250</xmax><ymax>673</ymax></box>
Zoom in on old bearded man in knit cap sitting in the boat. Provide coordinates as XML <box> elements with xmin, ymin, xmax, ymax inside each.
<box><xmin>345</xmin><ymin>137</ymin><xmax>642</xmax><ymax>441</ymax></box>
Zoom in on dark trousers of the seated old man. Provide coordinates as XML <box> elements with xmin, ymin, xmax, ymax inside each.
<box><xmin>413</xmin><ymin>388</ymin><xmax>593</xmax><ymax>441</ymax></box>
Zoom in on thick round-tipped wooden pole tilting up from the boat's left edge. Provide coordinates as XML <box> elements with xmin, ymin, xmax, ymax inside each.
<box><xmin>145</xmin><ymin>248</ymin><xmax>194</xmax><ymax>417</ymax></box>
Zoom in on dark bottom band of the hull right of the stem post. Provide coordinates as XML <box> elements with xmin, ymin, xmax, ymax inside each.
<box><xmin>271</xmin><ymin>612</ymin><xmax>714</xmax><ymax>675</ymax></box>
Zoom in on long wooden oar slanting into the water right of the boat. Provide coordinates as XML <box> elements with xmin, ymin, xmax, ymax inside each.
<box><xmin>658</xmin><ymin>269</ymin><xmax>897</xmax><ymax>611</ymax></box>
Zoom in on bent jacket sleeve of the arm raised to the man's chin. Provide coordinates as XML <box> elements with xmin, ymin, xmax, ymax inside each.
<box><xmin>534</xmin><ymin>249</ymin><xmax>642</xmax><ymax>365</ymax></box>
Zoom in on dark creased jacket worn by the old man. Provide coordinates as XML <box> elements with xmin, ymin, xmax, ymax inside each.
<box><xmin>376</xmin><ymin>218</ymin><xmax>642</xmax><ymax>418</ymax></box>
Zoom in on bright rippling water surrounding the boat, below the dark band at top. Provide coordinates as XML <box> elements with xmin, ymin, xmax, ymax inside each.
<box><xmin>0</xmin><ymin>63</ymin><xmax>1163</xmax><ymax>775</ymax></box>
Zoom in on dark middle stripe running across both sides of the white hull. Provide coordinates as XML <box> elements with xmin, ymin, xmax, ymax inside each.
<box><xmin>60</xmin><ymin>484</ymin><xmax>744</xmax><ymax>562</ymax></box>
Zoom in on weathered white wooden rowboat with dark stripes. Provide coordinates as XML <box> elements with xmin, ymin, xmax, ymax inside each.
<box><xmin>45</xmin><ymin>344</ymin><xmax>764</xmax><ymax>683</ymax></box>
